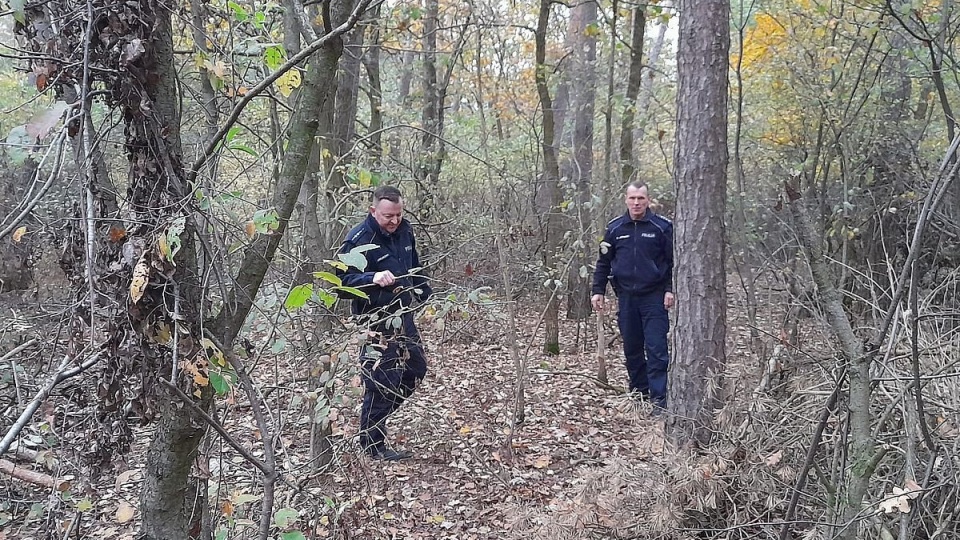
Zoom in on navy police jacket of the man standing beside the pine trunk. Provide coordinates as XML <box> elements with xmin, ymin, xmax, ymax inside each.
<box><xmin>592</xmin><ymin>209</ymin><xmax>673</xmax><ymax>296</ymax></box>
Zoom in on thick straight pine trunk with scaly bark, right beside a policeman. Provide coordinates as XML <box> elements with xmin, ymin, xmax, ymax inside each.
<box><xmin>667</xmin><ymin>0</ymin><xmax>730</xmax><ymax>446</ymax></box>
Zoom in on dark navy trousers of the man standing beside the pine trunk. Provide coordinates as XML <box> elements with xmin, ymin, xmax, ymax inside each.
<box><xmin>617</xmin><ymin>293</ymin><xmax>670</xmax><ymax>407</ymax></box>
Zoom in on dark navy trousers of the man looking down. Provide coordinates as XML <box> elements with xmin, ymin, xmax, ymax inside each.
<box><xmin>360</xmin><ymin>313</ymin><xmax>427</xmax><ymax>453</ymax></box>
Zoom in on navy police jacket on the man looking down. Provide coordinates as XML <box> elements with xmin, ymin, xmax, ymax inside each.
<box><xmin>337</xmin><ymin>214</ymin><xmax>431</xmax><ymax>315</ymax></box>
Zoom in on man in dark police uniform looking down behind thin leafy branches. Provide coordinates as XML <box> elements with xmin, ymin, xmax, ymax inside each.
<box><xmin>340</xmin><ymin>186</ymin><xmax>431</xmax><ymax>461</ymax></box>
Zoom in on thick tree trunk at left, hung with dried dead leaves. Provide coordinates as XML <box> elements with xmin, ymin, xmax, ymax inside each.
<box><xmin>132</xmin><ymin>2</ymin><xmax>211</xmax><ymax>540</ymax></box>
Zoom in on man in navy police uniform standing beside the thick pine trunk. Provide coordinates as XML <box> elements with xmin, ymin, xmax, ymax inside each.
<box><xmin>591</xmin><ymin>181</ymin><xmax>674</xmax><ymax>415</ymax></box>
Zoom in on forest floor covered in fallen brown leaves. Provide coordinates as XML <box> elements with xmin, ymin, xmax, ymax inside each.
<box><xmin>0</xmin><ymin>284</ymin><xmax>828</xmax><ymax>540</ymax></box>
